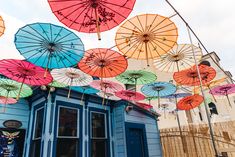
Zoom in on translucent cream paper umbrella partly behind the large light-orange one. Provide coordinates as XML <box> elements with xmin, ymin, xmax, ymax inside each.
<box><xmin>154</xmin><ymin>44</ymin><xmax>202</xmax><ymax>72</ymax></box>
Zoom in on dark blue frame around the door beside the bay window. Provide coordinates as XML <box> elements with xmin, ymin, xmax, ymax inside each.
<box><xmin>125</xmin><ymin>122</ymin><xmax>149</xmax><ymax>157</ymax></box>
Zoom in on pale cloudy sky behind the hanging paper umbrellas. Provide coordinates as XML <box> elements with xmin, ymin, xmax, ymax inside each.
<box><xmin>0</xmin><ymin>0</ymin><xmax>235</xmax><ymax>76</ymax></box>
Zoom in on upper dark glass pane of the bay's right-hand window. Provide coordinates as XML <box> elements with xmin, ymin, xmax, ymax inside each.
<box><xmin>92</xmin><ymin>113</ymin><xmax>106</xmax><ymax>138</ymax></box>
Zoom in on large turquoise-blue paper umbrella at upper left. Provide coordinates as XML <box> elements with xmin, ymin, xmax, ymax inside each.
<box><xmin>15</xmin><ymin>23</ymin><xmax>84</xmax><ymax>75</ymax></box>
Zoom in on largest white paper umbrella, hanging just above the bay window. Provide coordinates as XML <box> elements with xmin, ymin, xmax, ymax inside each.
<box><xmin>51</xmin><ymin>68</ymin><xmax>93</xmax><ymax>98</ymax></box>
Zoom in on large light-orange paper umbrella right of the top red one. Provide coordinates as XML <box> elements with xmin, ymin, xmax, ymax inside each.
<box><xmin>115</xmin><ymin>14</ymin><xmax>178</xmax><ymax>66</ymax></box>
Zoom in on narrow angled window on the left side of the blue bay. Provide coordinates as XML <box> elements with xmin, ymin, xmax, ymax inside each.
<box><xmin>30</xmin><ymin>107</ymin><xmax>44</xmax><ymax>157</ymax></box>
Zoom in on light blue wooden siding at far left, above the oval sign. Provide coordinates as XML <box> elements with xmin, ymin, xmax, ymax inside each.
<box><xmin>0</xmin><ymin>99</ymin><xmax>29</xmax><ymax>129</ymax></box>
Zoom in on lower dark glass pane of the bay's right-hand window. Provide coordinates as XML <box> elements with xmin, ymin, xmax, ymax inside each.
<box><xmin>92</xmin><ymin>140</ymin><xmax>106</xmax><ymax>157</ymax></box>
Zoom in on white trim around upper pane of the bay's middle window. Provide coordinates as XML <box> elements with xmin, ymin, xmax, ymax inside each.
<box><xmin>56</xmin><ymin>105</ymin><xmax>80</xmax><ymax>139</ymax></box>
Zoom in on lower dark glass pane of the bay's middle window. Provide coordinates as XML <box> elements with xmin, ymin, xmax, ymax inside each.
<box><xmin>56</xmin><ymin>138</ymin><xmax>79</xmax><ymax>157</ymax></box>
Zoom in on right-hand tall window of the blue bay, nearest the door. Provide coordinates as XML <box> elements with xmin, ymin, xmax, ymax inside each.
<box><xmin>91</xmin><ymin>112</ymin><xmax>108</xmax><ymax>157</ymax></box>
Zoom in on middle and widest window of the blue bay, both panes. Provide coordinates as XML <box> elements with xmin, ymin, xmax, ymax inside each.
<box><xmin>56</xmin><ymin>107</ymin><xmax>80</xmax><ymax>157</ymax></box>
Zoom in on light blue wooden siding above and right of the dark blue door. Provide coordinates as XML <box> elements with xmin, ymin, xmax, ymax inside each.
<box><xmin>125</xmin><ymin>110</ymin><xmax>162</xmax><ymax>157</ymax></box>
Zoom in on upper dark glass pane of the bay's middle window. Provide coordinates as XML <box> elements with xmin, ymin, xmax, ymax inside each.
<box><xmin>58</xmin><ymin>107</ymin><xmax>78</xmax><ymax>137</ymax></box>
